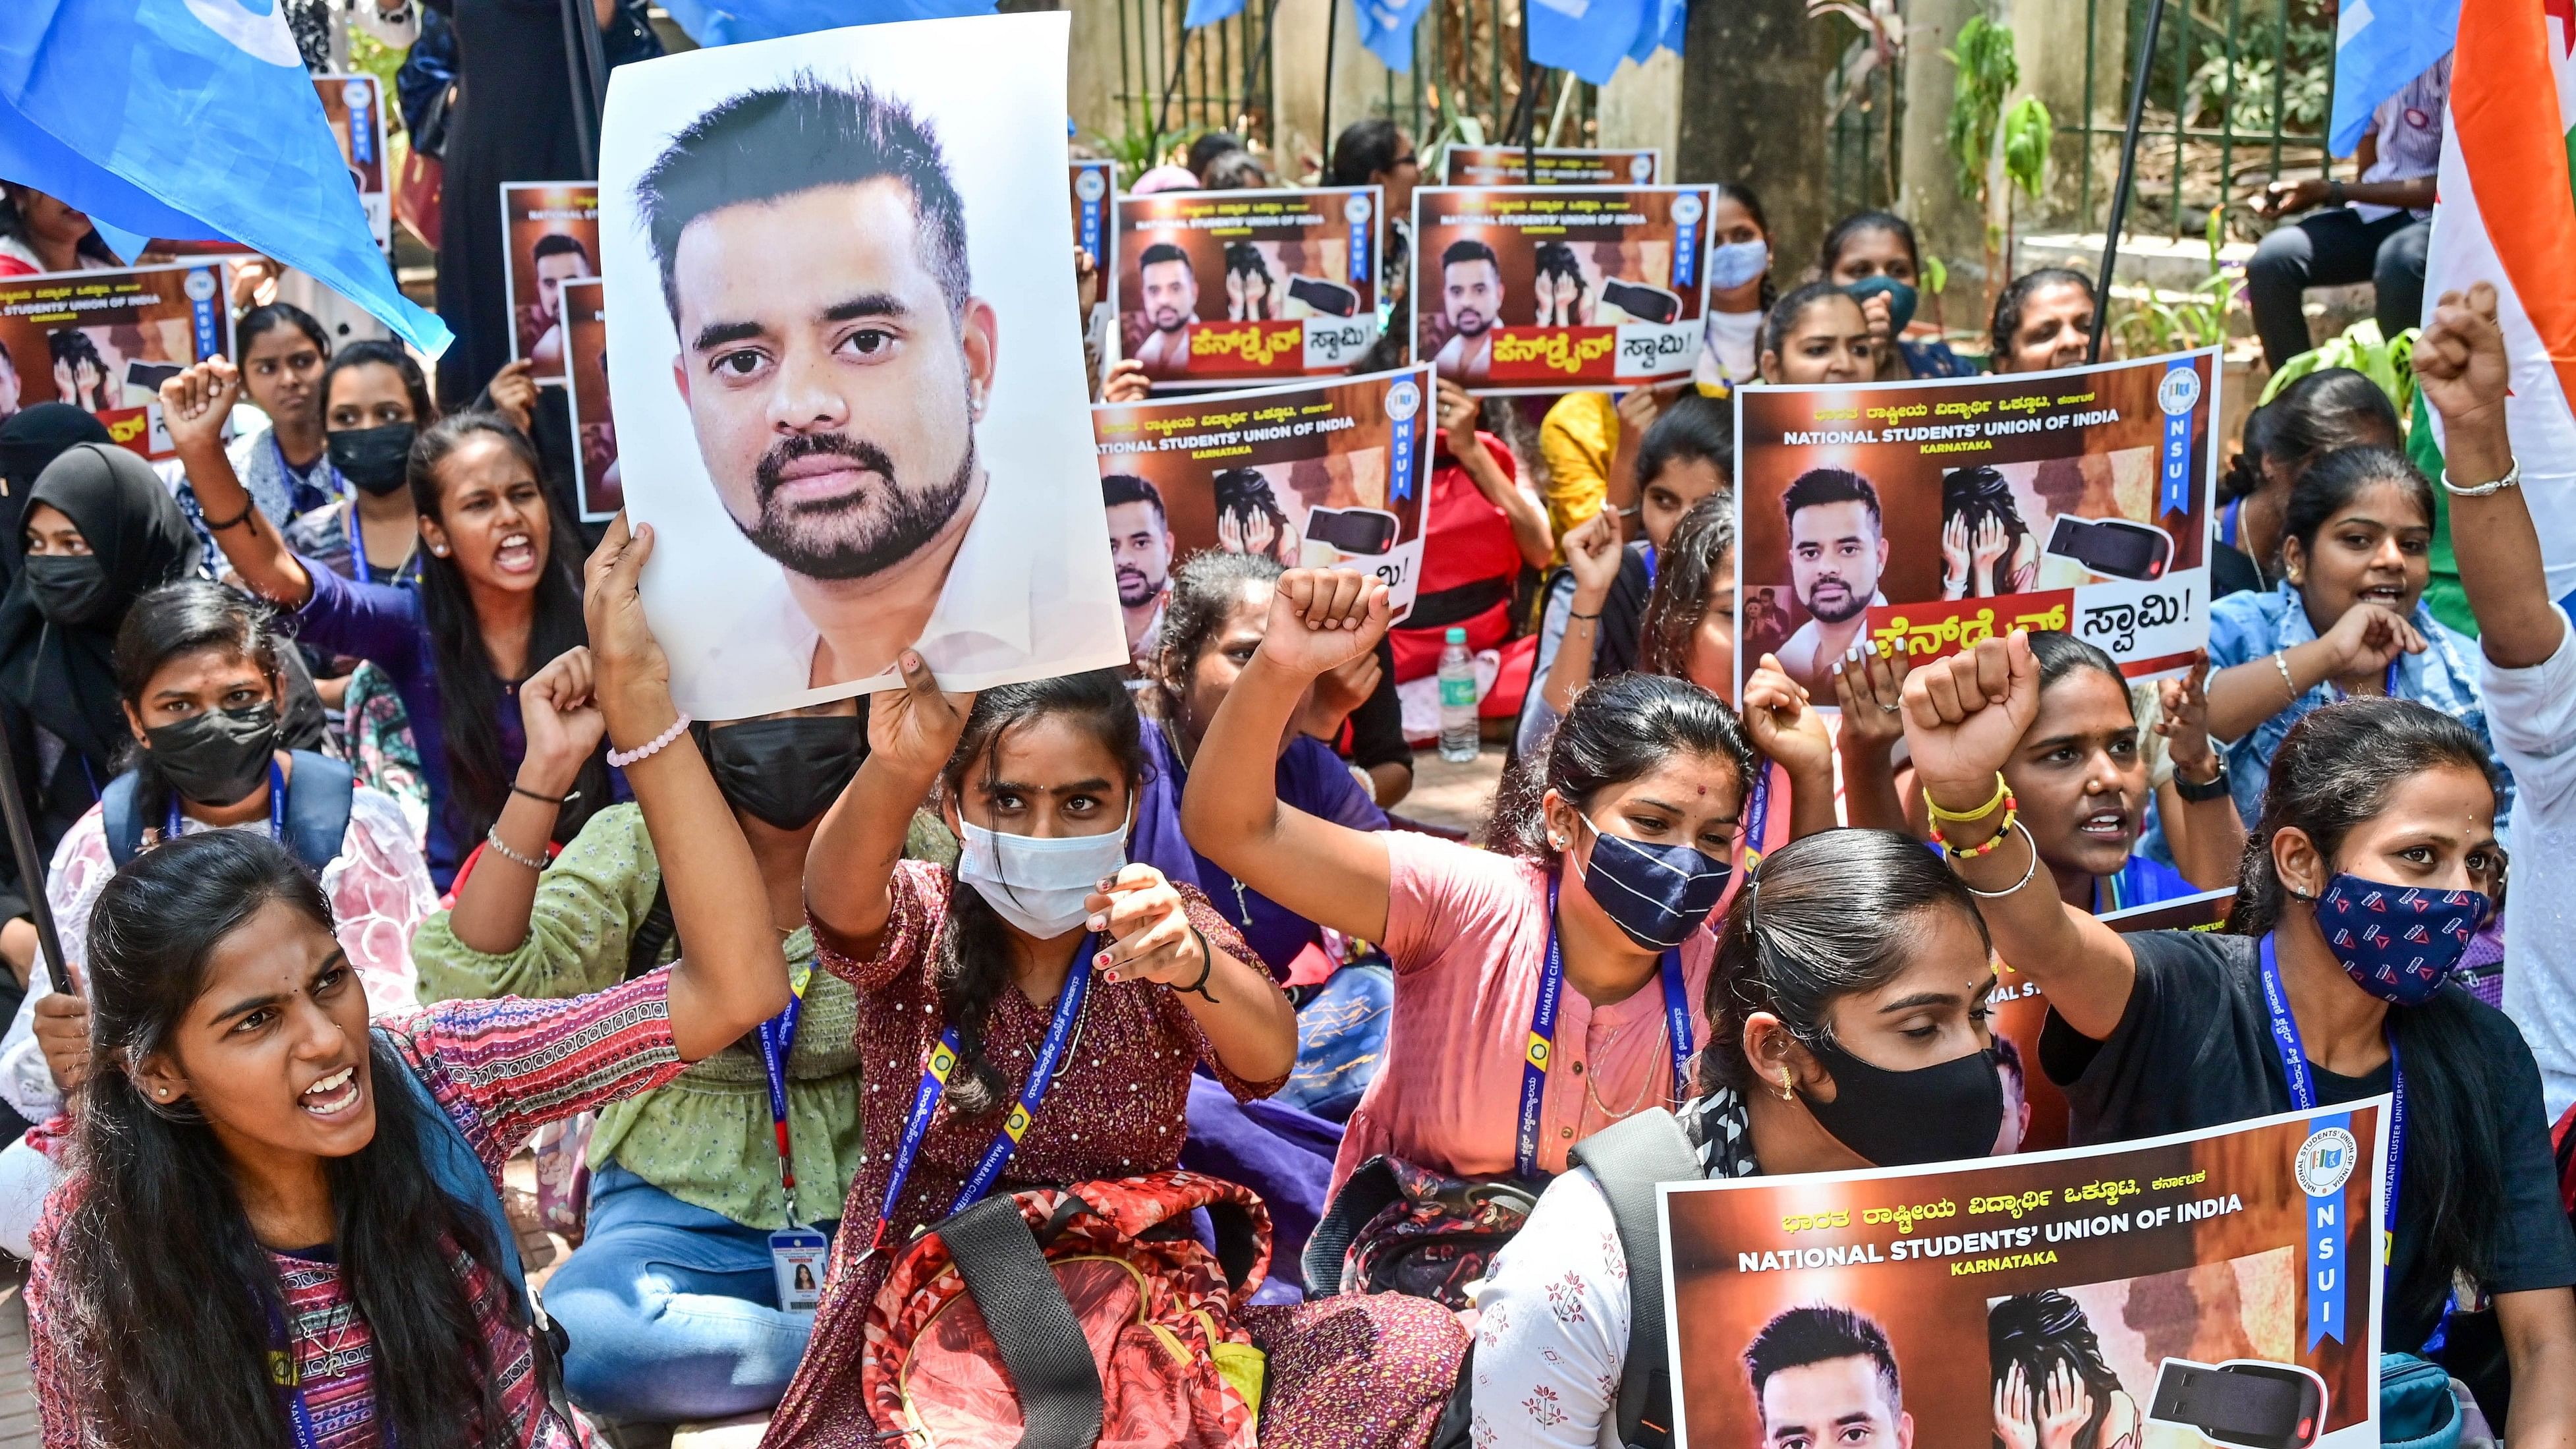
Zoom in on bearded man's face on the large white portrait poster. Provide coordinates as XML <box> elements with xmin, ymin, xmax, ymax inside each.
<box><xmin>673</xmin><ymin>178</ymin><xmax>997</xmax><ymax>580</ymax></box>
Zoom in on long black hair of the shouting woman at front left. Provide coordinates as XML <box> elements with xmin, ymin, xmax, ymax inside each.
<box><xmin>46</xmin><ymin>830</ymin><xmax>518</xmax><ymax>1449</ymax></box>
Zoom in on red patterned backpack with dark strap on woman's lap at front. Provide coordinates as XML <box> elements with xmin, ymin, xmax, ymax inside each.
<box><xmin>860</xmin><ymin>1170</ymin><xmax>1270</xmax><ymax>1449</ymax></box>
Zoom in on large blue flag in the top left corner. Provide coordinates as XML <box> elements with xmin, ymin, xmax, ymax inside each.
<box><xmin>0</xmin><ymin>0</ymin><xmax>448</xmax><ymax>356</ymax></box>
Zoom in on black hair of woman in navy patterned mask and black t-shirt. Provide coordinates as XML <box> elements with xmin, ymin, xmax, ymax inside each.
<box><xmin>2228</xmin><ymin>698</ymin><xmax>2504</xmax><ymax>1315</ymax></box>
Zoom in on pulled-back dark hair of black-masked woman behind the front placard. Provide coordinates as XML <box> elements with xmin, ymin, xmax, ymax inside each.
<box><xmin>1700</xmin><ymin>830</ymin><xmax>1986</xmax><ymax>1093</ymax></box>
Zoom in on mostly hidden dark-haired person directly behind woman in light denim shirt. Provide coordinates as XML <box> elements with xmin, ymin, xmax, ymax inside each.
<box><xmin>2210</xmin><ymin>366</ymin><xmax>2406</xmax><ymax>596</ymax></box>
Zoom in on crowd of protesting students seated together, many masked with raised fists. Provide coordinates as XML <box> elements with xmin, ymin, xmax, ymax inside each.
<box><xmin>0</xmin><ymin>65</ymin><xmax>2576</xmax><ymax>1449</ymax></box>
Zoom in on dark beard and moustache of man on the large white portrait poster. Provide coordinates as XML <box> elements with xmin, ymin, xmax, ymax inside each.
<box><xmin>737</xmin><ymin>428</ymin><xmax>976</xmax><ymax>577</ymax></box>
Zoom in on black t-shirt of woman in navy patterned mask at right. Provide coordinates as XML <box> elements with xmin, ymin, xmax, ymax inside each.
<box><xmin>2040</xmin><ymin>931</ymin><xmax>2576</xmax><ymax>1353</ymax></box>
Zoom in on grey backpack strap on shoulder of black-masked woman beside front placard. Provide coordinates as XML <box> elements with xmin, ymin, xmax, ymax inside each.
<box><xmin>1566</xmin><ymin>1109</ymin><xmax>1708</xmax><ymax>1444</ymax></box>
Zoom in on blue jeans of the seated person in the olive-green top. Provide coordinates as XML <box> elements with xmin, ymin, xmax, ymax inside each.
<box><xmin>544</xmin><ymin>1163</ymin><xmax>840</xmax><ymax>1423</ymax></box>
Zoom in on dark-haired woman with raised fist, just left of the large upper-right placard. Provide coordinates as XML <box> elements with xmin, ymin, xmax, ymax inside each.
<box><xmin>1520</xmin><ymin>395</ymin><xmax>1736</xmax><ymax>751</ymax></box>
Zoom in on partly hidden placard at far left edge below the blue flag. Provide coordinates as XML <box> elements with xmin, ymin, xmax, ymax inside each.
<box><xmin>0</xmin><ymin>260</ymin><xmax>232</xmax><ymax>459</ymax></box>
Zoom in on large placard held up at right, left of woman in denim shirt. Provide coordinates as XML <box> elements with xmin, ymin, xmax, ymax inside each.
<box><xmin>1736</xmin><ymin>351</ymin><xmax>2218</xmax><ymax>701</ymax></box>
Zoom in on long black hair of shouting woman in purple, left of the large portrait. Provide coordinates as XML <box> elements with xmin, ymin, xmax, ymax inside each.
<box><xmin>409</xmin><ymin>410</ymin><xmax>608</xmax><ymax>843</ymax></box>
